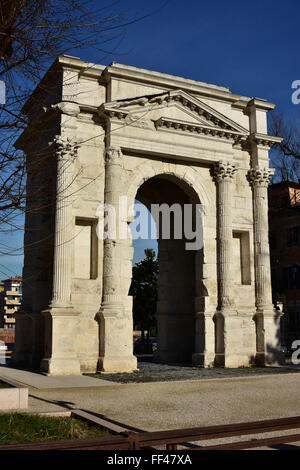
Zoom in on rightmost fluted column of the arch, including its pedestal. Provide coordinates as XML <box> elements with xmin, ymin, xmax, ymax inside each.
<box><xmin>248</xmin><ymin>166</ymin><xmax>283</xmax><ymax>365</ymax></box>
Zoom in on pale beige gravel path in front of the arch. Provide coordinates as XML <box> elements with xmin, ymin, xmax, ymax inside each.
<box><xmin>13</xmin><ymin>373</ymin><xmax>300</xmax><ymax>431</ymax></box>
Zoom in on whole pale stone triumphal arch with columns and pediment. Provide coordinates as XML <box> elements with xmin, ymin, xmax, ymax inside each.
<box><xmin>14</xmin><ymin>56</ymin><xmax>281</xmax><ymax>375</ymax></box>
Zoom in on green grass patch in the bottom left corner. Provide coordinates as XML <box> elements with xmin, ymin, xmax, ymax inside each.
<box><xmin>0</xmin><ymin>412</ymin><xmax>110</xmax><ymax>445</ymax></box>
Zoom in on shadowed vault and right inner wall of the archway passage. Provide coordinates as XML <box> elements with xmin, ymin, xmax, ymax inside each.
<box><xmin>129</xmin><ymin>174</ymin><xmax>203</xmax><ymax>363</ymax></box>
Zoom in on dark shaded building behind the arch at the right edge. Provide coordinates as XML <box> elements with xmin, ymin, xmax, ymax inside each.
<box><xmin>269</xmin><ymin>181</ymin><xmax>300</xmax><ymax>349</ymax></box>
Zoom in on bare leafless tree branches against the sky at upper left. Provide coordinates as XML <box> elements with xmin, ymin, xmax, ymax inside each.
<box><xmin>0</xmin><ymin>0</ymin><xmax>167</xmax><ymax>278</ymax></box>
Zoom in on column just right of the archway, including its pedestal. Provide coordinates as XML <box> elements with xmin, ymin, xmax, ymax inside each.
<box><xmin>214</xmin><ymin>161</ymin><xmax>241</xmax><ymax>367</ymax></box>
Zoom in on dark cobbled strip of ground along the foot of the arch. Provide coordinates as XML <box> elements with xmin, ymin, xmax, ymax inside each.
<box><xmin>87</xmin><ymin>357</ymin><xmax>300</xmax><ymax>383</ymax></box>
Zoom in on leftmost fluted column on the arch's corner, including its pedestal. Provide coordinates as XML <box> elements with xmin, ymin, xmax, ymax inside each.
<box><xmin>41</xmin><ymin>136</ymin><xmax>80</xmax><ymax>375</ymax></box>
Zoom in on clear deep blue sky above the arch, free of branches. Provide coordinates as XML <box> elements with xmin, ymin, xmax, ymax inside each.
<box><xmin>0</xmin><ymin>0</ymin><xmax>300</xmax><ymax>279</ymax></box>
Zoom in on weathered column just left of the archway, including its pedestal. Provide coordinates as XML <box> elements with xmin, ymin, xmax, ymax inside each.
<box><xmin>98</xmin><ymin>147</ymin><xmax>137</xmax><ymax>373</ymax></box>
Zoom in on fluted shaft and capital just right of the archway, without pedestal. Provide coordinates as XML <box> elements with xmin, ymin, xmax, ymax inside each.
<box><xmin>214</xmin><ymin>162</ymin><xmax>236</xmax><ymax>312</ymax></box>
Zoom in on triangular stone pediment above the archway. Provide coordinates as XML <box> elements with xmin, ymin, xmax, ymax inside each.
<box><xmin>99</xmin><ymin>90</ymin><xmax>249</xmax><ymax>142</ymax></box>
